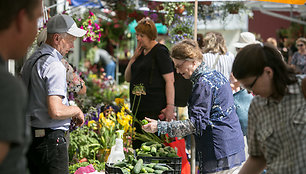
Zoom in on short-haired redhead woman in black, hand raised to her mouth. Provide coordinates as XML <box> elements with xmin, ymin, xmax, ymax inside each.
<box><xmin>125</xmin><ymin>18</ymin><xmax>175</xmax><ymax>148</ymax></box>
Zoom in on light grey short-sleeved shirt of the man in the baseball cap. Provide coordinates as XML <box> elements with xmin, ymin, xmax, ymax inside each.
<box><xmin>22</xmin><ymin>44</ymin><xmax>71</xmax><ymax>130</ymax></box>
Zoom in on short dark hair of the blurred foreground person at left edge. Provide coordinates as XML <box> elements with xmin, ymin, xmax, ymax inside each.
<box><xmin>0</xmin><ymin>0</ymin><xmax>41</xmax><ymax>31</ymax></box>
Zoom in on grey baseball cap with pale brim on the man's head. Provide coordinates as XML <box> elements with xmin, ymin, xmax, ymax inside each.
<box><xmin>47</xmin><ymin>14</ymin><xmax>86</xmax><ymax>37</ymax></box>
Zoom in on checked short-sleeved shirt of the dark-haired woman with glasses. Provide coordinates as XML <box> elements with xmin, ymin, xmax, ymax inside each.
<box><xmin>248</xmin><ymin>78</ymin><xmax>306</xmax><ymax>174</ymax></box>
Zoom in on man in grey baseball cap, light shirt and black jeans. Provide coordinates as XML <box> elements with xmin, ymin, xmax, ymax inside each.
<box><xmin>22</xmin><ymin>14</ymin><xmax>86</xmax><ymax>174</ymax></box>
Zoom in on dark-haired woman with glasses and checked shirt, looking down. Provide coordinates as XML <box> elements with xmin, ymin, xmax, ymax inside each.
<box><xmin>232</xmin><ymin>44</ymin><xmax>306</xmax><ymax>174</ymax></box>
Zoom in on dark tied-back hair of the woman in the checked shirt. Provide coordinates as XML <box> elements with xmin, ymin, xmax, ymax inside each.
<box><xmin>232</xmin><ymin>44</ymin><xmax>297</xmax><ymax>96</ymax></box>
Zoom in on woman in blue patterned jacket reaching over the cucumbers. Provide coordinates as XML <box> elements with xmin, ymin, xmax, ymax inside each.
<box><xmin>143</xmin><ymin>40</ymin><xmax>245</xmax><ymax>173</ymax></box>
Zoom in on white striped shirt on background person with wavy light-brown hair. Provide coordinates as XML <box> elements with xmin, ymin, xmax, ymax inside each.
<box><xmin>203</xmin><ymin>52</ymin><xmax>235</xmax><ymax>80</ymax></box>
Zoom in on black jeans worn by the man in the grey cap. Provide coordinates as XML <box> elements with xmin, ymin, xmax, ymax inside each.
<box><xmin>27</xmin><ymin>129</ymin><xmax>69</xmax><ymax>174</ymax></box>
